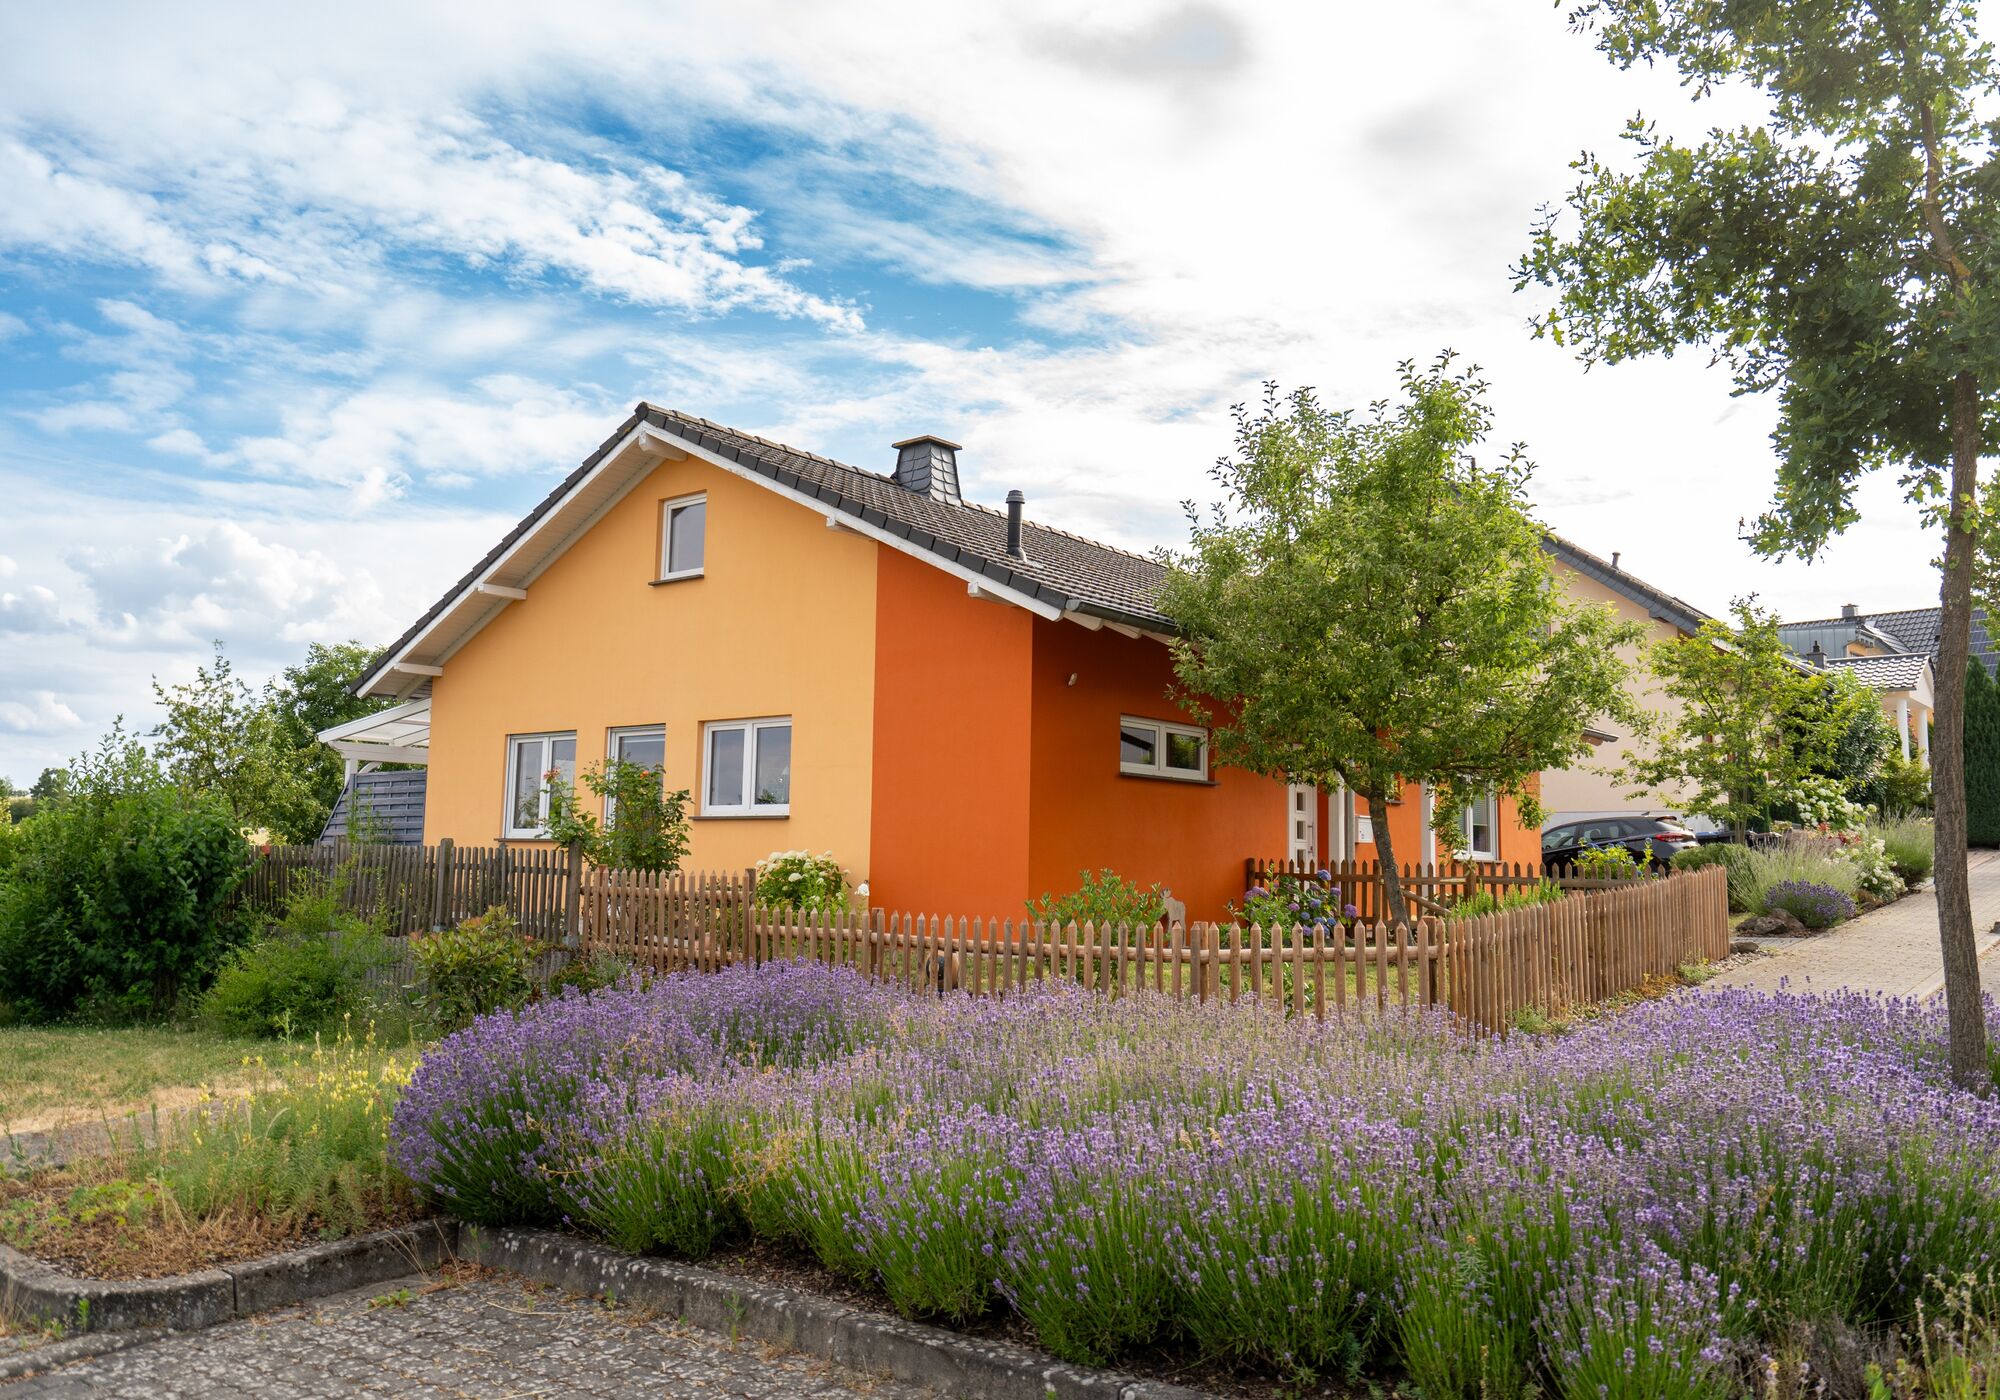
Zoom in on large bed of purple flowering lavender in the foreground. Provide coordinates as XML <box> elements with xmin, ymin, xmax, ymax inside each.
<box><xmin>394</xmin><ymin>964</ymin><xmax>2000</xmax><ymax>1400</ymax></box>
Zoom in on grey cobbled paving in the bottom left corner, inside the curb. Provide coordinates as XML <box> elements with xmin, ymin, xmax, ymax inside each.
<box><xmin>0</xmin><ymin>1276</ymin><xmax>932</xmax><ymax>1400</ymax></box>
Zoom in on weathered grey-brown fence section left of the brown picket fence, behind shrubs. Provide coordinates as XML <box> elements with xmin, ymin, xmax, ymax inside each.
<box><xmin>236</xmin><ymin>840</ymin><xmax>572</xmax><ymax>942</ymax></box>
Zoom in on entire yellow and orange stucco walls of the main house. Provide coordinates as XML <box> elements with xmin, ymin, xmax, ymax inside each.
<box><xmin>424</xmin><ymin>448</ymin><xmax>1540</xmax><ymax>918</ymax></box>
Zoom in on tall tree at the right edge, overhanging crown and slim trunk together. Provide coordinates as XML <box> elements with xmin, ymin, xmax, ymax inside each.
<box><xmin>1518</xmin><ymin>0</ymin><xmax>2000</xmax><ymax>1086</ymax></box>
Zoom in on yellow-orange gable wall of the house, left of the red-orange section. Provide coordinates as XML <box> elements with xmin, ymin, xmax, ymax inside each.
<box><xmin>424</xmin><ymin>460</ymin><xmax>878</xmax><ymax>878</ymax></box>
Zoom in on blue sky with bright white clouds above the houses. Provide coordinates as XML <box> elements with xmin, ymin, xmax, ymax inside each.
<box><xmin>0</xmin><ymin>0</ymin><xmax>1934</xmax><ymax>782</ymax></box>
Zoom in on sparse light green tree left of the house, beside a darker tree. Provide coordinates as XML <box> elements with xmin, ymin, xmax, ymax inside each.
<box><xmin>152</xmin><ymin>642</ymin><xmax>304</xmax><ymax>834</ymax></box>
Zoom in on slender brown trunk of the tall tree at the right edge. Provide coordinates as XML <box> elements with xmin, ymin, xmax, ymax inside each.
<box><xmin>1930</xmin><ymin>374</ymin><xmax>1994</xmax><ymax>1092</ymax></box>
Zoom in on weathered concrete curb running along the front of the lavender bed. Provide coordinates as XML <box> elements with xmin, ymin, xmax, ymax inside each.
<box><xmin>458</xmin><ymin>1224</ymin><xmax>1204</xmax><ymax>1400</ymax></box>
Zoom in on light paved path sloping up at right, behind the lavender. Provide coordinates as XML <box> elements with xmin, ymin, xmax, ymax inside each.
<box><xmin>1702</xmin><ymin>850</ymin><xmax>2000</xmax><ymax>996</ymax></box>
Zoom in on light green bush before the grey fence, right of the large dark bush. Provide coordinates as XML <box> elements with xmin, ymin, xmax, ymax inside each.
<box><xmin>200</xmin><ymin>872</ymin><xmax>394</xmax><ymax>1038</ymax></box>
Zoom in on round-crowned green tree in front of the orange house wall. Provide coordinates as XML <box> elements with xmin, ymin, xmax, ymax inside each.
<box><xmin>1160</xmin><ymin>354</ymin><xmax>1640</xmax><ymax>920</ymax></box>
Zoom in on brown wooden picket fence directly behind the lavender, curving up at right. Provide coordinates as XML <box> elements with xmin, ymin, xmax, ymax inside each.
<box><xmin>578</xmin><ymin>868</ymin><xmax>1728</xmax><ymax>1032</ymax></box>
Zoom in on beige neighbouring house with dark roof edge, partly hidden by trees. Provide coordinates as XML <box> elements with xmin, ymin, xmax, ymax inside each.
<box><xmin>1542</xmin><ymin>534</ymin><xmax>1708</xmax><ymax>826</ymax></box>
